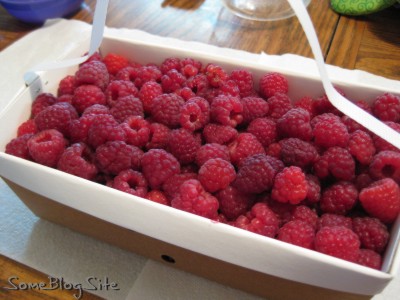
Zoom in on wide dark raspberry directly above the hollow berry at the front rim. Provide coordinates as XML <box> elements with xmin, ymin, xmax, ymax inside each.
<box><xmin>95</xmin><ymin>141</ymin><xmax>143</xmax><ymax>175</ymax></box>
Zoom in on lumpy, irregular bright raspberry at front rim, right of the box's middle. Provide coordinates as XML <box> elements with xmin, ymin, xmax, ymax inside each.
<box><xmin>233</xmin><ymin>202</ymin><xmax>279</xmax><ymax>238</ymax></box>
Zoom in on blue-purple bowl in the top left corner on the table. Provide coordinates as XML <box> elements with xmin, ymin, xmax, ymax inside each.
<box><xmin>0</xmin><ymin>0</ymin><xmax>83</xmax><ymax>24</ymax></box>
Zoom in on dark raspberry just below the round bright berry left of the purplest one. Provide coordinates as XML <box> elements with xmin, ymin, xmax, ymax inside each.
<box><xmin>216</xmin><ymin>186</ymin><xmax>254</xmax><ymax>221</ymax></box>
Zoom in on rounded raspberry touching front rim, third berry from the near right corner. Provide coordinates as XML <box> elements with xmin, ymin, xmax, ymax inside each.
<box><xmin>277</xmin><ymin>220</ymin><xmax>315</xmax><ymax>249</ymax></box>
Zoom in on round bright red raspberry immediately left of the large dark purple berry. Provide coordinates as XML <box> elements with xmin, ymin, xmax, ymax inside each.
<box><xmin>198</xmin><ymin>158</ymin><xmax>236</xmax><ymax>193</ymax></box>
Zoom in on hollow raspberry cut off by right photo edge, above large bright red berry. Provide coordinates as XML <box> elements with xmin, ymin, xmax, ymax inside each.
<box><xmin>369</xmin><ymin>150</ymin><xmax>400</xmax><ymax>183</ymax></box>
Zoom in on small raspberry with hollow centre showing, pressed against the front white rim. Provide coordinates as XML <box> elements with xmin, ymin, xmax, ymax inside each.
<box><xmin>112</xmin><ymin>169</ymin><xmax>147</xmax><ymax>197</ymax></box>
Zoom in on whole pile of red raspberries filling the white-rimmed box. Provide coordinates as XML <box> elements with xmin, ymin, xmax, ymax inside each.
<box><xmin>6</xmin><ymin>53</ymin><xmax>400</xmax><ymax>269</ymax></box>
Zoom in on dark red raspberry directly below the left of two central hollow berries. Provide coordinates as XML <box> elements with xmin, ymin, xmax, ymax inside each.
<box><xmin>167</xmin><ymin>128</ymin><xmax>201</xmax><ymax>164</ymax></box>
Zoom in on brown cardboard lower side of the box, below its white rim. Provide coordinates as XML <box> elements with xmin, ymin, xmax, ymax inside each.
<box><xmin>5</xmin><ymin>179</ymin><xmax>371</xmax><ymax>300</ymax></box>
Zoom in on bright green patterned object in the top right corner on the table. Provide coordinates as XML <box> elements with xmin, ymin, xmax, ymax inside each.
<box><xmin>331</xmin><ymin>0</ymin><xmax>398</xmax><ymax>16</ymax></box>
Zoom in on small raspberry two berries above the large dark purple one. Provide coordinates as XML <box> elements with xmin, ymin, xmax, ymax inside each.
<box><xmin>247</xmin><ymin>118</ymin><xmax>277</xmax><ymax>147</ymax></box>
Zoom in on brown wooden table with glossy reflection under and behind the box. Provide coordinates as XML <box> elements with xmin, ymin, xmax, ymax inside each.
<box><xmin>0</xmin><ymin>0</ymin><xmax>400</xmax><ymax>299</ymax></box>
